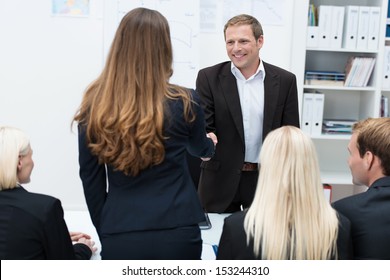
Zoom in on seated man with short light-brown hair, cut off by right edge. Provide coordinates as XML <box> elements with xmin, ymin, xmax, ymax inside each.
<box><xmin>333</xmin><ymin>118</ymin><xmax>390</xmax><ymax>260</ymax></box>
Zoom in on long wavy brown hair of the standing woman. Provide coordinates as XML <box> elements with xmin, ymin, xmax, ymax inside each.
<box><xmin>74</xmin><ymin>8</ymin><xmax>194</xmax><ymax>175</ymax></box>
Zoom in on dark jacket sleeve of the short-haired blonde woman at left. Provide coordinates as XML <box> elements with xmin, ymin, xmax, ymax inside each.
<box><xmin>44</xmin><ymin>199</ymin><xmax>92</xmax><ymax>260</ymax></box>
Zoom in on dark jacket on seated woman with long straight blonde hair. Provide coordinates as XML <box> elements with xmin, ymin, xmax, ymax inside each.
<box><xmin>217</xmin><ymin>211</ymin><xmax>353</xmax><ymax>260</ymax></box>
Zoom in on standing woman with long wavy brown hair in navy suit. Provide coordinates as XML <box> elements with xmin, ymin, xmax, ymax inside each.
<box><xmin>75</xmin><ymin>8</ymin><xmax>216</xmax><ymax>260</ymax></box>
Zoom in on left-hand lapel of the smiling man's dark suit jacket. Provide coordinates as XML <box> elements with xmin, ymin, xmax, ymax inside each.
<box><xmin>219</xmin><ymin>63</ymin><xmax>244</xmax><ymax>143</ymax></box>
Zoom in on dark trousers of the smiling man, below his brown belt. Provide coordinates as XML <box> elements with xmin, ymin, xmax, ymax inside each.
<box><xmin>224</xmin><ymin>171</ymin><xmax>259</xmax><ymax>213</ymax></box>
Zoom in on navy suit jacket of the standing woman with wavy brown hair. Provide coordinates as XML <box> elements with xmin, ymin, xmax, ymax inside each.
<box><xmin>79</xmin><ymin>91</ymin><xmax>214</xmax><ymax>237</ymax></box>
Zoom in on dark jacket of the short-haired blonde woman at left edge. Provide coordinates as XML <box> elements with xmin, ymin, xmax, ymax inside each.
<box><xmin>0</xmin><ymin>187</ymin><xmax>92</xmax><ymax>260</ymax></box>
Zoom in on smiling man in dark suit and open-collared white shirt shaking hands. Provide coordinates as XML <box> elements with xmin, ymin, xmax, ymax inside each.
<box><xmin>196</xmin><ymin>15</ymin><xmax>299</xmax><ymax>213</ymax></box>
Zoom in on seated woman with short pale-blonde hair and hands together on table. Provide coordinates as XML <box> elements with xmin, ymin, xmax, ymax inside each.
<box><xmin>0</xmin><ymin>126</ymin><xmax>96</xmax><ymax>260</ymax></box>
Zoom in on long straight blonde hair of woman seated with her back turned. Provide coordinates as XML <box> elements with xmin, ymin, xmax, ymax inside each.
<box><xmin>244</xmin><ymin>126</ymin><xmax>338</xmax><ymax>260</ymax></box>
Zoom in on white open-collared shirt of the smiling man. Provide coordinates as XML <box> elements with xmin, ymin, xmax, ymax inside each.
<box><xmin>231</xmin><ymin>61</ymin><xmax>265</xmax><ymax>163</ymax></box>
